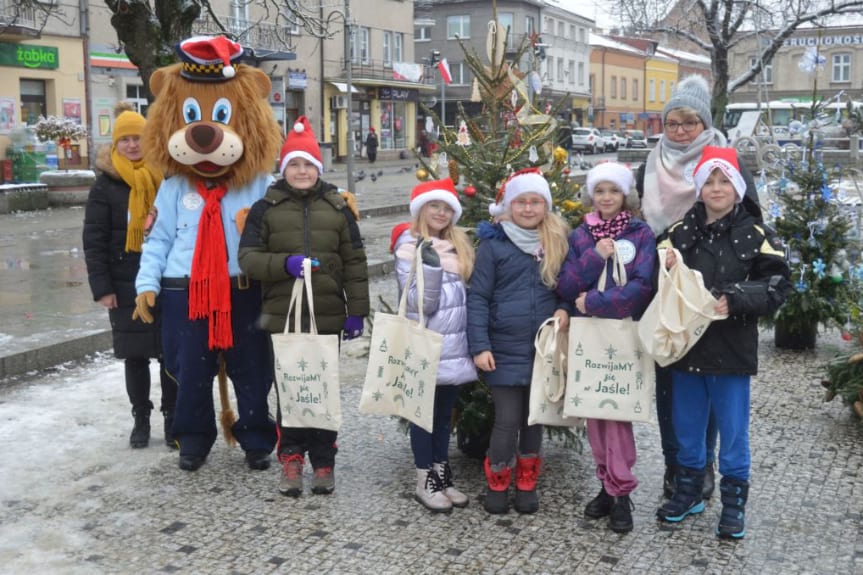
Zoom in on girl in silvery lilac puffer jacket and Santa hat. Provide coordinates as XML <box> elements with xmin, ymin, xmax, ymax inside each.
<box><xmin>391</xmin><ymin>178</ymin><xmax>476</xmax><ymax>513</ymax></box>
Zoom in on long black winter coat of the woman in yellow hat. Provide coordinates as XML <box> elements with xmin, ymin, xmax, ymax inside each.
<box><xmin>83</xmin><ymin>150</ymin><xmax>162</xmax><ymax>359</ymax></box>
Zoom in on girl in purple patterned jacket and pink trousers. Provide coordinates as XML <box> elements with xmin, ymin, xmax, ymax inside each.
<box><xmin>557</xmin><ymin>162</ymin><xmax>656</xmax><ymax>533</ymax></box>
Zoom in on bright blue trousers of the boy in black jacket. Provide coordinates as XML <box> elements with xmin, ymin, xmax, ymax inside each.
<box><xmin>672</xmin><ymin>371</ymin><xmax>751</xmax><ymax>481</ymax></box>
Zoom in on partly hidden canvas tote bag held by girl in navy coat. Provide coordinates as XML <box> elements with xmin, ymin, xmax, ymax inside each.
<box><xmin>527</xmin><ymin>317</ymin><xmax>582</xmax><ymax>427</ymax></box>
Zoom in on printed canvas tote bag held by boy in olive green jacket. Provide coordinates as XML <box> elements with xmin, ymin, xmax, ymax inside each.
<box><xmin>272</xmin><ymin>258</ymin><xmax>342</xmax><ymax>431</ymax></box>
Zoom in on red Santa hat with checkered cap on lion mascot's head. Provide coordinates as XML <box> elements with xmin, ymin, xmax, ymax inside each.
<box><xmin>175</xmin><ymin>36</ymin><xmax>243</xmax><ymax>82</ymax></box>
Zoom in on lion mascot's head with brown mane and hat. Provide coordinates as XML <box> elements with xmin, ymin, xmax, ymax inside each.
<box><xmin>142</xmin><ymin>36</ymin><xmax>281</xmax><ymax>186</ymax></box>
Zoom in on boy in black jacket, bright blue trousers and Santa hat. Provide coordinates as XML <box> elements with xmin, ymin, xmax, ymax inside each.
<box><xmin>657</xmin><ymin>146</ymin><xmax>791</xmax><ymax>539</ymax></box>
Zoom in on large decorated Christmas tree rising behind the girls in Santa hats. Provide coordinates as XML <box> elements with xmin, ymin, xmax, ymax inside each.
<box><xmin>416</xmin><ymin>10</ymin><xmax>584</xmax><ymax>229</ymax></box>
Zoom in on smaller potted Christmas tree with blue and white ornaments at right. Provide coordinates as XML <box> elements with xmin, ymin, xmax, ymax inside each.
<box><xmin>769</xmin><ymin>48</ymin><xmax>852</xmax><ymax>348</ymax></box>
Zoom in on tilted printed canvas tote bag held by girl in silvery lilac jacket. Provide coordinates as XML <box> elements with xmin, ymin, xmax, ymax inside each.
<box><xmin>359</xmin><ymin>249</ymin><xmax>443</xmax><ymax>433</ymax></box>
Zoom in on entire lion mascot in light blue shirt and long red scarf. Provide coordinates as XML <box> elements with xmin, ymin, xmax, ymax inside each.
<box><xmin>135</xmin><ymin>36</ymin><xmax>281</xmax><ymax>471</ymax></box>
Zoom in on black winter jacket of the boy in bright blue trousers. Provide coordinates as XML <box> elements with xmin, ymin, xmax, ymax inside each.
<box><xmin>659</xmin><ymin>202</ymin><xmax>791</xmax><ymax>375</ymax></box>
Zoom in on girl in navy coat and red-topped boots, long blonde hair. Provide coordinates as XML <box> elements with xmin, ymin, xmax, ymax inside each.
<box><xmin>467</xmin><ymin>168</ymin><xmax>571</xmax><ymax>513</ymax></box>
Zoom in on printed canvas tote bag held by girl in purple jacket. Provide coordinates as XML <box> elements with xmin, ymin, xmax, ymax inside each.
<box><xmin>563</xmin><ymin>245</ymin><xmax>656</xmax><ymax>421</ymax></box>
